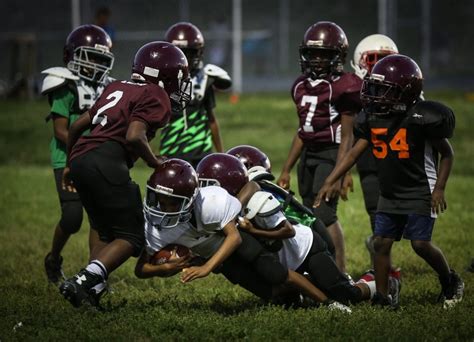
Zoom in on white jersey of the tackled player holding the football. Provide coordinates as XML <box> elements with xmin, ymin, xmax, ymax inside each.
<box><xmin>145</xmin><ymin>186</ymin><xmax>241</xmax><ymax>258</ymax></box>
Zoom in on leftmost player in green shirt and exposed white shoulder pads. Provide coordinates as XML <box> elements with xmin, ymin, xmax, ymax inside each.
<box><xmin>41</xmin><ymin>25</ymin><xmax>114</xmax><ymax>284</ymax></box>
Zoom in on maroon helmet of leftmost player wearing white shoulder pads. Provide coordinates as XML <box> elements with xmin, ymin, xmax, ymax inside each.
<box><xmin>63</xmin><ymin>25</ymin><xmax>114</xmax><ymax>83</ymax></box>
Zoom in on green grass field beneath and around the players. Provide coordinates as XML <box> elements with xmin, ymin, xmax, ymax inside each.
<box><xmin>0</xmin><ymin>93</ymin><xmax>474</xmax><ymax>341</ymax></box>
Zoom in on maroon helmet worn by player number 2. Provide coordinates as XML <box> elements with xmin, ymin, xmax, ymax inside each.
<box><xmin>132</xmin><ymin>41</ymin><xmax>191</xmax><ymax>109</ymax></box>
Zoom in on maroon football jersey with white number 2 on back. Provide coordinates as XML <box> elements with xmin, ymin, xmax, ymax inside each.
<box><xmin>70</xmin><ymin>81</ymin><xmax>171</xmax><ymax>164</ymax></box>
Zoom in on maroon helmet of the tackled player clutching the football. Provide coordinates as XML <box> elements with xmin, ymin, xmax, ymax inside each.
<box><xmin>143</xmin><ymin>159</ymin><xmax>199</xmax><ymax>228</ymax></box>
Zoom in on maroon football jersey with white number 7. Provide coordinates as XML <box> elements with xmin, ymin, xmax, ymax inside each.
<box><xmin>291</xmin><ymin>73</ymin><xmax>362</xmax><ymax>148</ymax></box>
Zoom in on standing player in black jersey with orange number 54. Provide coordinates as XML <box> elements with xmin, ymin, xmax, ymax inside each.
<box><xmin>315</xmin><ymin>54</ymin><xmax>464</xmax><ymax>308</ymax></box>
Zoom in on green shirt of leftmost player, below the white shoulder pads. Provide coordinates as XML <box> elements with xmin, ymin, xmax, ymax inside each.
<box><xmin>49</xmin><ymin>86</ymin><xmax>81</xmax><ymax>169</ymax></box>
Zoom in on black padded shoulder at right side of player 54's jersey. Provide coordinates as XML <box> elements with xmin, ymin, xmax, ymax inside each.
<box><xmin>409</xmin><ymin>101</ymin><xmax>456</xmax><ymax>139</ymax></box>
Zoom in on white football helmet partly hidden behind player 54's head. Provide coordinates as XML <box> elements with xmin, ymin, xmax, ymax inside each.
<box><xmin>351</xmin><ymin>34</ymin><xmax>398</xmax><ymax>78</ymax></box>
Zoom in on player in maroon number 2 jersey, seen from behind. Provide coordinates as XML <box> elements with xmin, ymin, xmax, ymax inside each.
<box><xmin>59</xmin><ymin>41</ymin><xmax>190</xmax><ymax>307</ymax></box>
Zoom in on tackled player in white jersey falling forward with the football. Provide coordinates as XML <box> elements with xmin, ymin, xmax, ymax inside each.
<box><xmin>135</xmin><ymin>156</ymin><xmax>350</xmax><ymax>308</ymax></box>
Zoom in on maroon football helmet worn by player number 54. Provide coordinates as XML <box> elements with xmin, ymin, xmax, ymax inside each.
<box><xmin>360</xmin><ymin>54</ymin><xmax>423</xmax><ymax>115</ymax></box>
